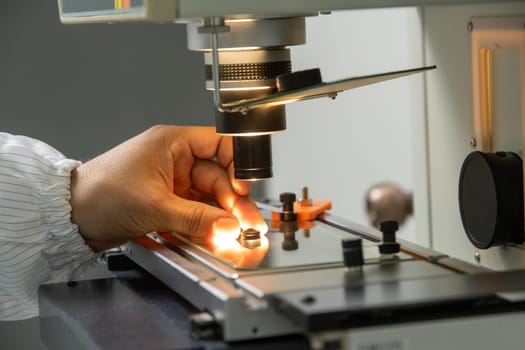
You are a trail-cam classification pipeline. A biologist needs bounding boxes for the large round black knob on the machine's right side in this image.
[459,151,524,249]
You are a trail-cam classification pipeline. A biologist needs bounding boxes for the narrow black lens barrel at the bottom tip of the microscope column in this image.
[233,135,273,180]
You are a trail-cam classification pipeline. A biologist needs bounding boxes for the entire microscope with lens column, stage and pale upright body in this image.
[36,0,525,350]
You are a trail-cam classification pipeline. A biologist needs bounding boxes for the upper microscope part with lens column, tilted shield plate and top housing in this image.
[59,1,435,181]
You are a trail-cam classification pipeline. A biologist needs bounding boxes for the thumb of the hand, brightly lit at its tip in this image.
[161,195,240,239]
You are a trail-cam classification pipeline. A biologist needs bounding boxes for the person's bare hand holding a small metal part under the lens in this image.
[70,126,267,251]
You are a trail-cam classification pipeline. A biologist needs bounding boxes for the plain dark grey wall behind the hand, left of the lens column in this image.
[0,0,213,350]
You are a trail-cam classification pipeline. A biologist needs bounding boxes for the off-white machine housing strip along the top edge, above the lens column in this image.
[59,0,516,23]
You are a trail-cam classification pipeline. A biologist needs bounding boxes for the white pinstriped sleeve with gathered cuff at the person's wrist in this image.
[0,133,95,321]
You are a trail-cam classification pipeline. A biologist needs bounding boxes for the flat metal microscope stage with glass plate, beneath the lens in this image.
[119,203,525,344]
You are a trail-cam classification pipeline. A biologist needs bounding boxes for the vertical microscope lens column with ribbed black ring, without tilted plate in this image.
[187,17,305,181]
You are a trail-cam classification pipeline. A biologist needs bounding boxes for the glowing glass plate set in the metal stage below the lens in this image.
[160,221,411,271]
